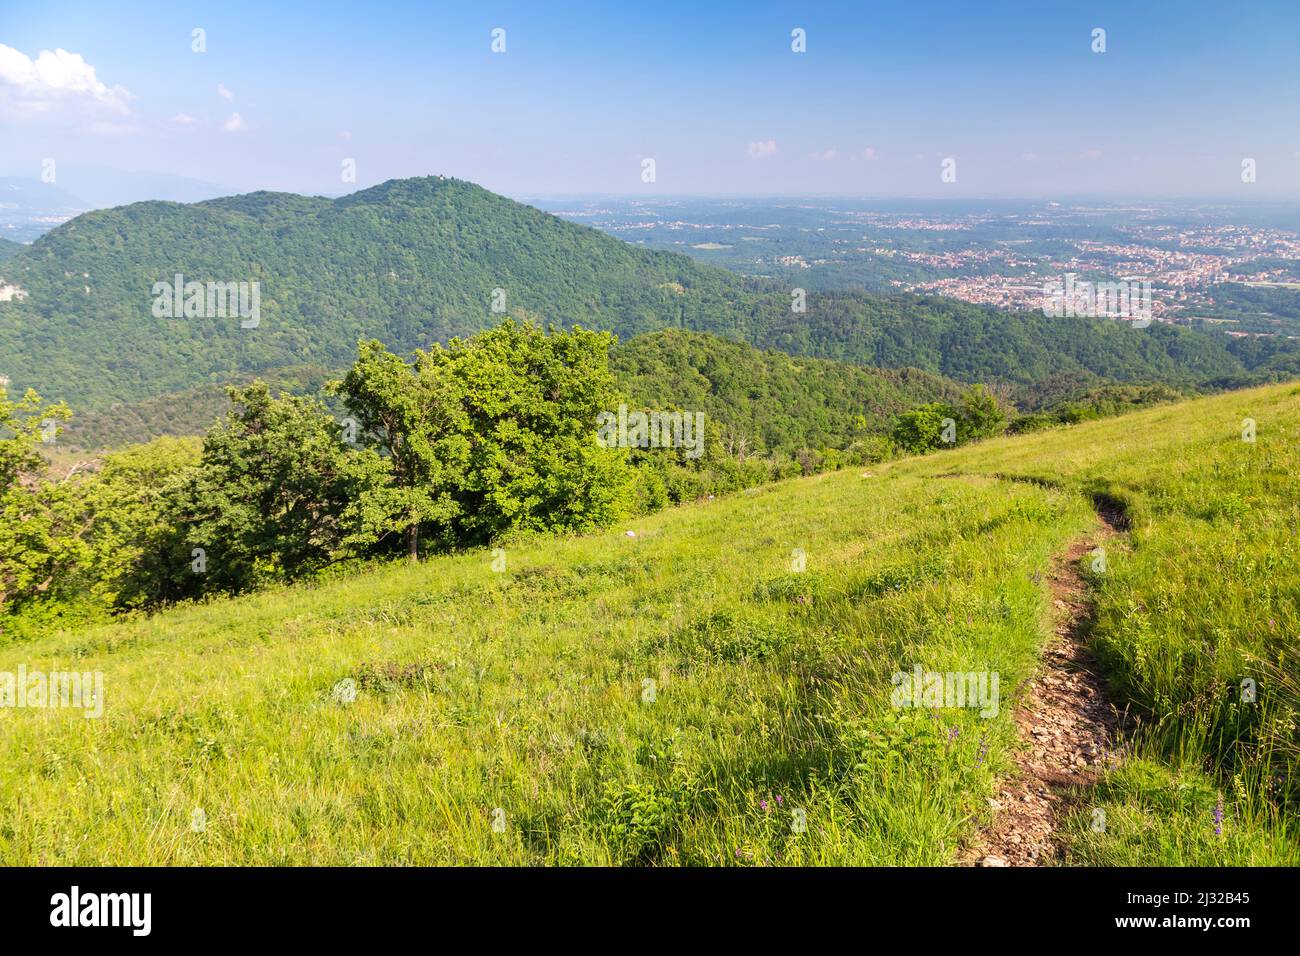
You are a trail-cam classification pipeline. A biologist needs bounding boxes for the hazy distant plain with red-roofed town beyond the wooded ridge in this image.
[537,199,1300,337]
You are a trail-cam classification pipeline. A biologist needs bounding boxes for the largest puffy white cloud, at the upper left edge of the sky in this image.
[0,43,131,118]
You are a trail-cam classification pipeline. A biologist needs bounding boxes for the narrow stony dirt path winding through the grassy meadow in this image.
[967,502,1127,866]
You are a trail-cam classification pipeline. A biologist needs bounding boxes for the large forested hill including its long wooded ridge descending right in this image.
[0,177,1292,408]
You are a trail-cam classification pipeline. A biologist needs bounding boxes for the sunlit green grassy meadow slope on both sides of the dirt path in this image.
[0,384,1300,865]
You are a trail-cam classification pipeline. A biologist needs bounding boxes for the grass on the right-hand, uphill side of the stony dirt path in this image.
[904,384,1300,865]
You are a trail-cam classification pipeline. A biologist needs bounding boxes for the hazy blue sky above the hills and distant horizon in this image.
[0,0,1300,199]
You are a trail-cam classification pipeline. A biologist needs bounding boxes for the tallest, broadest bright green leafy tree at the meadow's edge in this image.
[337,320,632,559]
